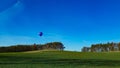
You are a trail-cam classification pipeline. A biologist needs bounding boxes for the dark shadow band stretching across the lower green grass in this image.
[0,56,120,66]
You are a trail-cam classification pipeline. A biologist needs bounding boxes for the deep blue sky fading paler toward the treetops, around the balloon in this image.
[0,0,120,51]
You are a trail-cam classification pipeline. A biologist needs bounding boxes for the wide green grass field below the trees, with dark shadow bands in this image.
[0,51,120,68]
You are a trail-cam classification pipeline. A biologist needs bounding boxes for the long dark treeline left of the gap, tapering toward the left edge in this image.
[0,42,65,52]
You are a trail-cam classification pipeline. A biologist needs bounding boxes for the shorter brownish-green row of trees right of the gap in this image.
[82,42,120,52]
